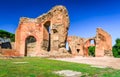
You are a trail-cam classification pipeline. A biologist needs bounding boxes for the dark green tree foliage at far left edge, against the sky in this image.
[0,30,15,42]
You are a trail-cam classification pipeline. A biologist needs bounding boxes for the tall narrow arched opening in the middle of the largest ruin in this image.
[42,21,51,51]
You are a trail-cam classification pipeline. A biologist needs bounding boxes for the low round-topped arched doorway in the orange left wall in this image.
[24,36,36,56]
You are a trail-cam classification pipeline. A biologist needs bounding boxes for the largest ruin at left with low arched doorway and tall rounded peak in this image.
[15,6,69,56]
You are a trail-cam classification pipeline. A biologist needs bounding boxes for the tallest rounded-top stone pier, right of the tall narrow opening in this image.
[51,6,69,52]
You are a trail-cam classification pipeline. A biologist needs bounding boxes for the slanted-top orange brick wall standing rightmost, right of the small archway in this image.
[95,28,112,56]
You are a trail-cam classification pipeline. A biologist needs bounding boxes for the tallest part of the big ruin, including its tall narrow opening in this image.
[37,6,69,52]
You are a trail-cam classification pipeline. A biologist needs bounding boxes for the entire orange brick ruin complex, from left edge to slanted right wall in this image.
[0,5,112,57]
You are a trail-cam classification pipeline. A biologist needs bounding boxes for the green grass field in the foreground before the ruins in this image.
[0,57,120,77]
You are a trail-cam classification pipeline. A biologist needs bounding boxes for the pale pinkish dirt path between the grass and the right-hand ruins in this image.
[52,56,120,69]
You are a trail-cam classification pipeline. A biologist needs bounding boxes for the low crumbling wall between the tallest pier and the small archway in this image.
[67,36,95,56]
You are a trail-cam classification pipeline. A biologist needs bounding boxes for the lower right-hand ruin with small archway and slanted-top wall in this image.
[67,28,112,57]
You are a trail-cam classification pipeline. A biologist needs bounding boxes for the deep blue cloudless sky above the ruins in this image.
[0,0,120,45]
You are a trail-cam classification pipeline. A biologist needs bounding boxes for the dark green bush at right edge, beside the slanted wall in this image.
[112,38,120,57]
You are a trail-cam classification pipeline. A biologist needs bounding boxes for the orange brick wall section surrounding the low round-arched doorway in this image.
[15,17,43,56]
